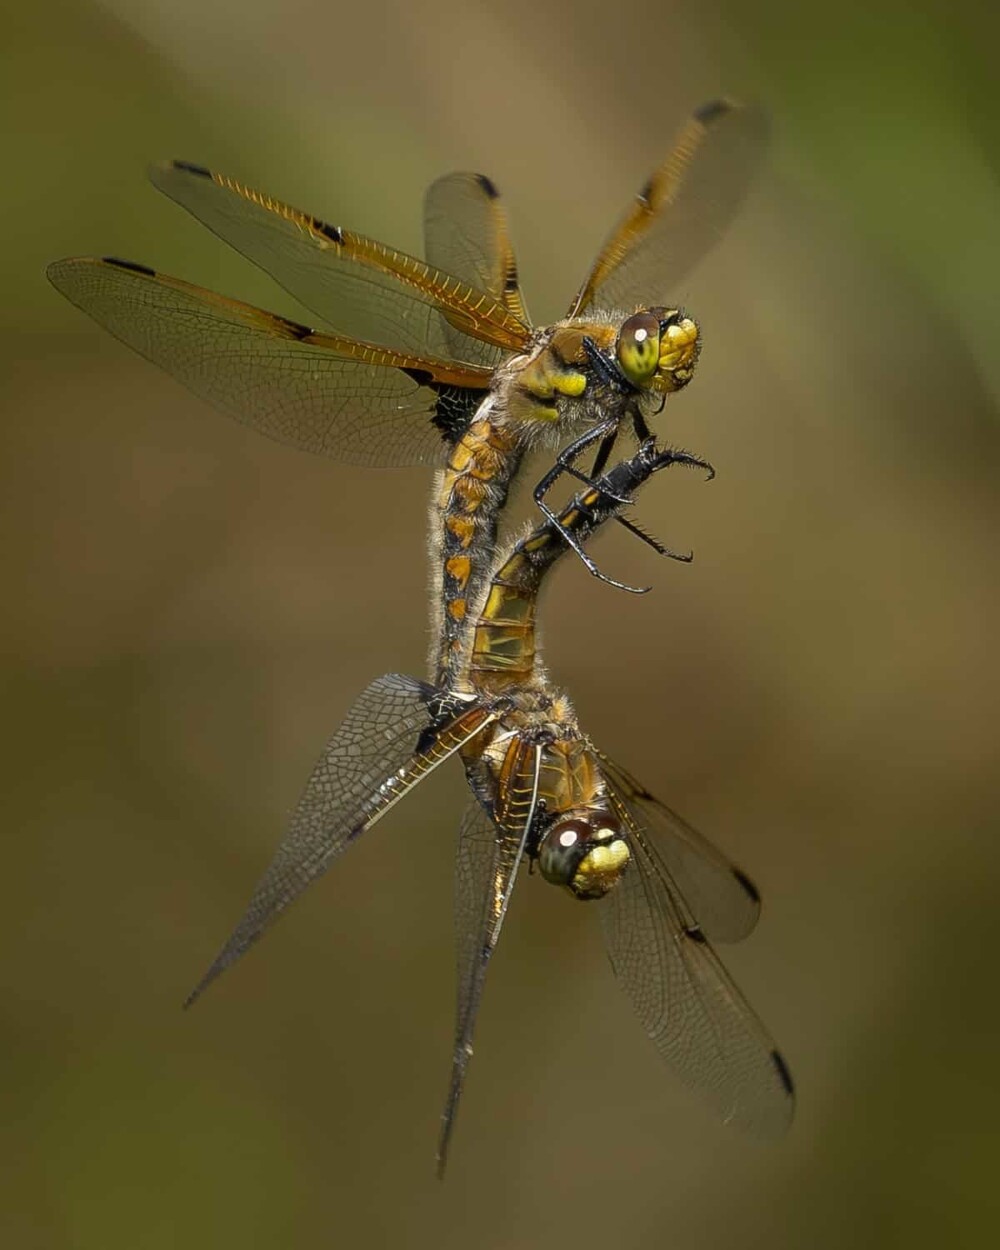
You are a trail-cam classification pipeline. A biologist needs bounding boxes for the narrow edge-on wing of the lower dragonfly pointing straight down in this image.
[438,739,540,1175]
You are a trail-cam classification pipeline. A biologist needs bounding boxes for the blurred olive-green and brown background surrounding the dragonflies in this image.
[0,0,1000,1250]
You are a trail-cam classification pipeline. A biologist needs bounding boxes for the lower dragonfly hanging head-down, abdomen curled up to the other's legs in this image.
[188,439,794,1174]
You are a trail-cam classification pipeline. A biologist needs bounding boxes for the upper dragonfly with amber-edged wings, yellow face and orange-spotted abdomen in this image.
[48,100,768,685]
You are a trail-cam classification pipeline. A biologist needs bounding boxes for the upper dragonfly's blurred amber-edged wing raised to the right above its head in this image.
[570,100,769,315]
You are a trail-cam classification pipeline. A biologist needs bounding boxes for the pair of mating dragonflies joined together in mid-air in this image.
[49,101,794,1168]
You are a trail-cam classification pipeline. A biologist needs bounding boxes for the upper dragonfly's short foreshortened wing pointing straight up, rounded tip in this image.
[424,173,528,366]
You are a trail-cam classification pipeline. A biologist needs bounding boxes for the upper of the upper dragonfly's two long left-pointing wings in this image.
[150,161,529,360]
